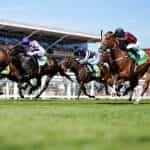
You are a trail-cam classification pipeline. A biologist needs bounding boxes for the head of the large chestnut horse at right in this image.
[100,31,119,51]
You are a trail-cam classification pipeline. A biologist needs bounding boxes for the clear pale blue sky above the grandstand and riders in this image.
[0,0,150,47]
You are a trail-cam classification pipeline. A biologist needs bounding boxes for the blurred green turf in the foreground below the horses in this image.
[0,100,150,150]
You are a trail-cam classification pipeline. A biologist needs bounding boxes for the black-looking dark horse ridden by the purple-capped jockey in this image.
[10,45,72,98]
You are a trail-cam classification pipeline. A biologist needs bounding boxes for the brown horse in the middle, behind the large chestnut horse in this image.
[60,57,112,100]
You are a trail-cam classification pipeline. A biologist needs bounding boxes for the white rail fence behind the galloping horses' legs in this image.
[0,74,150,99]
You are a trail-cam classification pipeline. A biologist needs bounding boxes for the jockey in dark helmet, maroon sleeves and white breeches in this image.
[114,28,140,58]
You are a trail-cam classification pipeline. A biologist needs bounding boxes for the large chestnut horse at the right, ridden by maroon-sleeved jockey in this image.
[100,32,150,101]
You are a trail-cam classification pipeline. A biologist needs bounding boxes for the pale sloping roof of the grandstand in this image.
[0,20,99,42]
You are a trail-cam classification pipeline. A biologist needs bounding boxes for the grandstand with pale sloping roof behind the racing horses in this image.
[0,21,99,61]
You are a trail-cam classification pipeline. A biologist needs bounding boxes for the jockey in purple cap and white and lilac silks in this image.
[21,37,47,66]
